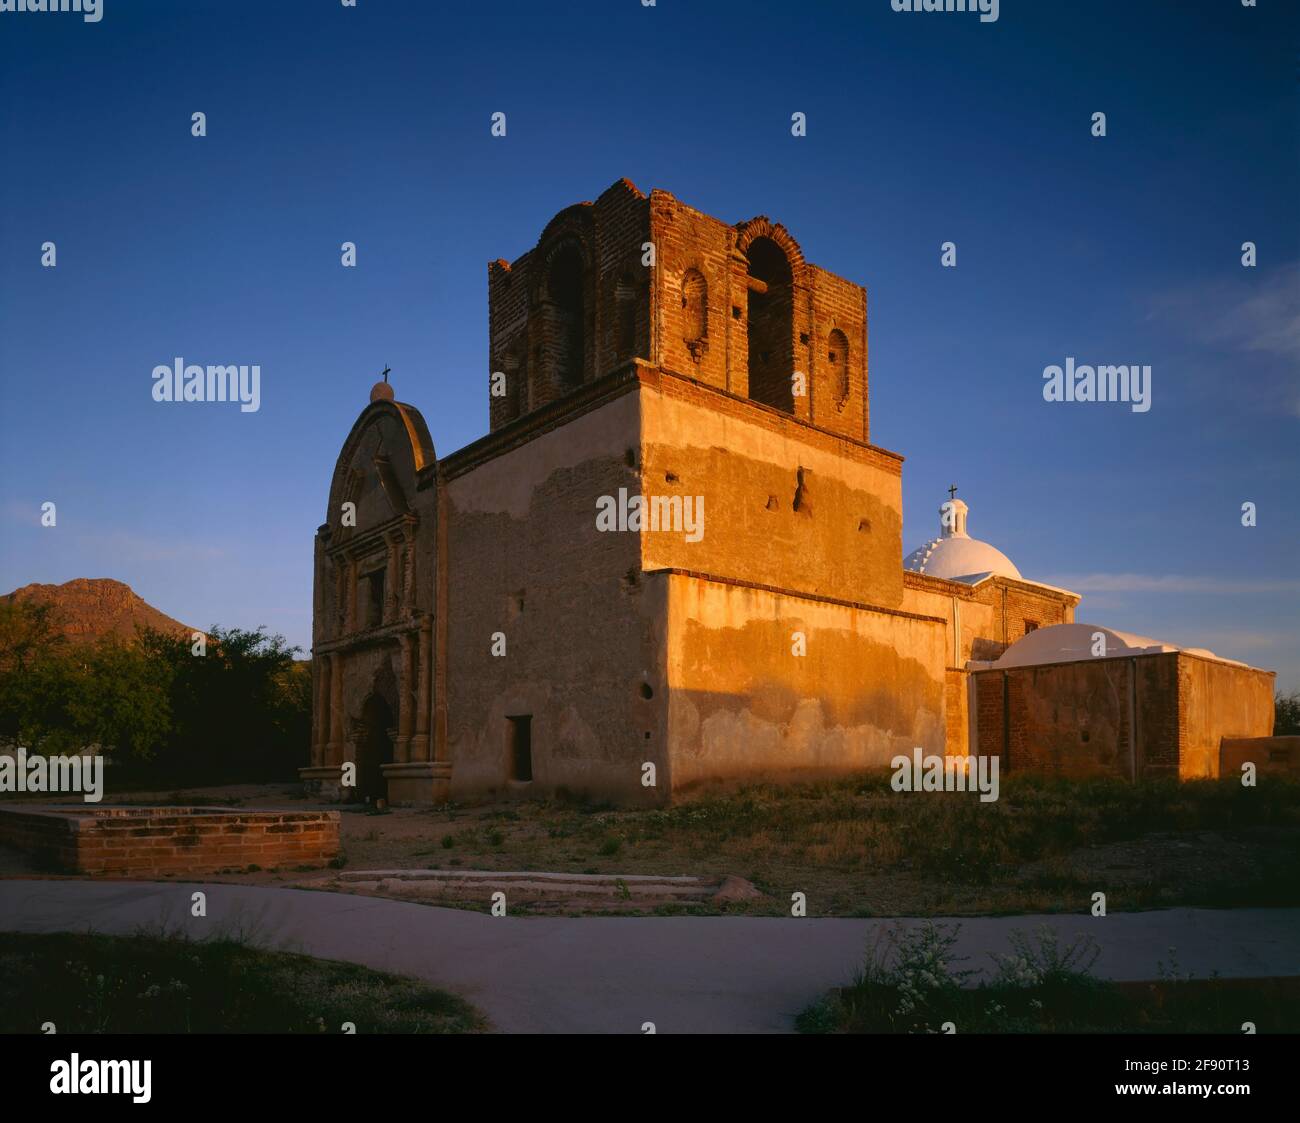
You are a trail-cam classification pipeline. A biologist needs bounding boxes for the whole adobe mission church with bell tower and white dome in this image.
[302,179,1273,806]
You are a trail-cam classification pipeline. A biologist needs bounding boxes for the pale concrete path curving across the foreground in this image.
[0,880,1300,1033]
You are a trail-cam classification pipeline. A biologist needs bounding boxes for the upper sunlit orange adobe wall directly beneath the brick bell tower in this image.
[640,370,902,608]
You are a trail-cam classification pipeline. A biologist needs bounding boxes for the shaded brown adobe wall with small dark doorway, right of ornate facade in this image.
[443,393,666,805]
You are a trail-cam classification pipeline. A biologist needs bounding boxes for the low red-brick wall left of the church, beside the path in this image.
[0,807,339,876]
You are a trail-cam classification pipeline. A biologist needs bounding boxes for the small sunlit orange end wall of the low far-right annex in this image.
[1178,652,1274,780]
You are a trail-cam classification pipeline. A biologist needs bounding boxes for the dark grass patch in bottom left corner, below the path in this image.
[0,933,486,1033]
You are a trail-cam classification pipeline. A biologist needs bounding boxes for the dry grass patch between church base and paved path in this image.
[332,769,1300,916]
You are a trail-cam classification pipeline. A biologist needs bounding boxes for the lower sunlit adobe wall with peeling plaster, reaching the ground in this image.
[665,572,944,794]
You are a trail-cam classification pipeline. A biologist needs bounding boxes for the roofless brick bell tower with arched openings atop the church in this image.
[488,179,870,442]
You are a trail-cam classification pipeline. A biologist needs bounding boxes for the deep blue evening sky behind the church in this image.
[0,0,1300,690]
